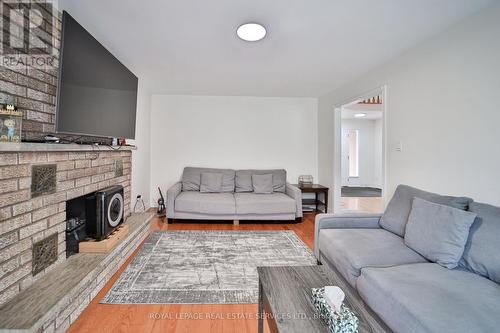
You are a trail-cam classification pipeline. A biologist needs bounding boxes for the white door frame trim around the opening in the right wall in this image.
[332,85,388,213]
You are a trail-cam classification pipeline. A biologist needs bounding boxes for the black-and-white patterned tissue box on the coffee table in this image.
[312,288,359,333]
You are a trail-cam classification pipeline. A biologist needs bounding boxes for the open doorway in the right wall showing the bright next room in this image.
[334,87,386,213]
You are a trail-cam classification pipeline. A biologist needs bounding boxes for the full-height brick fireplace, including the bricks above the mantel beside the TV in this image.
[0,1,137,306]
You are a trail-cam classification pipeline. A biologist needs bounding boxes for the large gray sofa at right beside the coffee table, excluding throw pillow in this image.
[315,185,500,333]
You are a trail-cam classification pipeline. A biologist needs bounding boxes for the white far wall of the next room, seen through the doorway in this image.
[342,119,382,188]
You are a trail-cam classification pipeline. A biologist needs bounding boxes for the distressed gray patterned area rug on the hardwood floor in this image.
[101,231,316,304]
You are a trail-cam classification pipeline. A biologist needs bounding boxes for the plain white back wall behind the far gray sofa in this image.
[151,95,318,200]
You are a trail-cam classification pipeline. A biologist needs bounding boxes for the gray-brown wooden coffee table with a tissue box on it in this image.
[257,265,391,333]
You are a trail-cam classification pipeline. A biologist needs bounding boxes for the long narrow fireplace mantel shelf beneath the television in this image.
[0,142,137,152]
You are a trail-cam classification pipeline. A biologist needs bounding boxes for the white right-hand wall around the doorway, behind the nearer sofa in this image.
[318,5,500,205]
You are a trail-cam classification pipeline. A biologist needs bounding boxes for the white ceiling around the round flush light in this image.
[59,0,495,97]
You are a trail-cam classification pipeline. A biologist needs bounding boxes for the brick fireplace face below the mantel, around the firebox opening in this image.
[0,151,132,305]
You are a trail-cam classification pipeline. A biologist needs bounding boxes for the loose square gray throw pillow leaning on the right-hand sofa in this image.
[404,198,477,269]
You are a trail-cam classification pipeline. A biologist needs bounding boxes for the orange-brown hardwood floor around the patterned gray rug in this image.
[68,213,315,333]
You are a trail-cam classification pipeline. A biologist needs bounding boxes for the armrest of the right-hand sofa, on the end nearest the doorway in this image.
[314,214,382,260]
